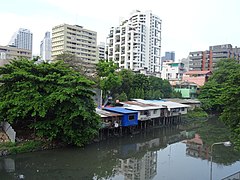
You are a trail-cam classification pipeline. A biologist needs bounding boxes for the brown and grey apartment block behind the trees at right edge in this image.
[189,44,240,71]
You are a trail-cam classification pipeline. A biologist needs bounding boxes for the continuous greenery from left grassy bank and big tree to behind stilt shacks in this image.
[0,53,182,153]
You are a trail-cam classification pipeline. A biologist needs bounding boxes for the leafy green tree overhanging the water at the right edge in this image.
[199,59,240,149]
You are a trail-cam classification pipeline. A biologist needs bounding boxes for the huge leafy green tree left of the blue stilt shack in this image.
[0,59,100,146]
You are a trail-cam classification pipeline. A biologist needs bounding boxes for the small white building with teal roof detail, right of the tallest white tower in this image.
[161,60,184,81]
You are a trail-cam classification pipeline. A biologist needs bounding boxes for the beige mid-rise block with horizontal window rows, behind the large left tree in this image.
[52,24,98,73]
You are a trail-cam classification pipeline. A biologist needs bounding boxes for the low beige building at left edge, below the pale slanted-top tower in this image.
[0,46,32,66]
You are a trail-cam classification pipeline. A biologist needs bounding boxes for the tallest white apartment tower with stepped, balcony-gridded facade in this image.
[107,10,162,72]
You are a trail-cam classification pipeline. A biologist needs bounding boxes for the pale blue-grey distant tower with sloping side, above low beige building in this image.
[9,28,33,51]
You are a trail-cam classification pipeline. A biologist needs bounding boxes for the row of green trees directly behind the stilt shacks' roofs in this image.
[94,60,174,103]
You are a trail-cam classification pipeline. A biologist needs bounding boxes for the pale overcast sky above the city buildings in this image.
[0,0,240,60]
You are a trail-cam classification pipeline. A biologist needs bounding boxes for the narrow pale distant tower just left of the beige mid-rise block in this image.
[40,32,52,61]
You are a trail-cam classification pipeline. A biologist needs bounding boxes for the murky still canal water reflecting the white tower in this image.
[0,117,240,180]
